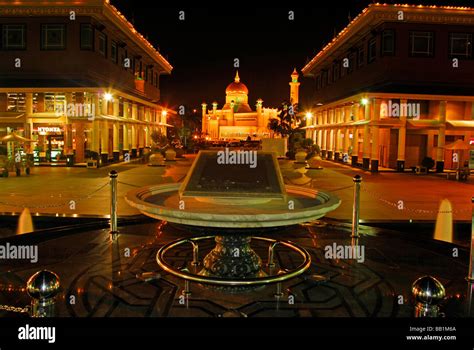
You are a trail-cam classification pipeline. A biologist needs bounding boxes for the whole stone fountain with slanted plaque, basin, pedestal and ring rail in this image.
[126,151,340,291]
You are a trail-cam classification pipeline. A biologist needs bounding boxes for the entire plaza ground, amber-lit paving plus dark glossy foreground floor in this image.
[0,156,474,317]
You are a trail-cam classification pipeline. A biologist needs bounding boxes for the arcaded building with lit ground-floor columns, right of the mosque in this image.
[302,4,474,172]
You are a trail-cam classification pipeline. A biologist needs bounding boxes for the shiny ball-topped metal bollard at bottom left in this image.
[26,270,60,317]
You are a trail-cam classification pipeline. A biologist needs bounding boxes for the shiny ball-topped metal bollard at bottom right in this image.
[411,276,446,317]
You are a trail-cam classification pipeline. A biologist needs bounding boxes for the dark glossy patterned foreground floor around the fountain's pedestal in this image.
[0,219,468,317]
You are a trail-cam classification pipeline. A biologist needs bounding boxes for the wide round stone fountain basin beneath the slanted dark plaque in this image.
[125,183,341,228]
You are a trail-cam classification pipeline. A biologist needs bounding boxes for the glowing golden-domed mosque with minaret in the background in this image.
[202,69,300,140]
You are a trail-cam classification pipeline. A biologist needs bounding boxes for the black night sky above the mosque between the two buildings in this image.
[111,0,472,111]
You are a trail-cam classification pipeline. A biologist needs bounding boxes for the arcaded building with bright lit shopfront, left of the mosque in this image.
[0,0,173,165]
